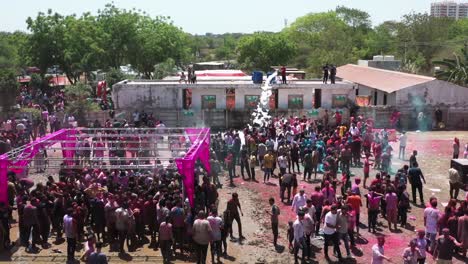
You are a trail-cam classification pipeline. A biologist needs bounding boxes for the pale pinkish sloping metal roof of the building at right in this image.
[336,64,435,93]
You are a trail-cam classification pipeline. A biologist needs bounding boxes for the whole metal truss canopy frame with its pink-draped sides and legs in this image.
[0,127,210,206]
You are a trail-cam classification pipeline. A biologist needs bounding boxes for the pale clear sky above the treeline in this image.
[0,0,446,34]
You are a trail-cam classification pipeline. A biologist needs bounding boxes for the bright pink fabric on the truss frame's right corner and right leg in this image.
[176,128,211,206]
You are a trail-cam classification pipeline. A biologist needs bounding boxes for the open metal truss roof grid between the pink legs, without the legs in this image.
[1,127,205,170]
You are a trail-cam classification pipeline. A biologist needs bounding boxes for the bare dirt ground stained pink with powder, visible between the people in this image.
[0,132,468,264]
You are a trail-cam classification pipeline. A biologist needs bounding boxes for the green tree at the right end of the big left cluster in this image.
[129,17,188,79]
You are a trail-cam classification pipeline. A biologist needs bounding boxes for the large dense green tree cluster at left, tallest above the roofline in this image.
[27,4,189,80]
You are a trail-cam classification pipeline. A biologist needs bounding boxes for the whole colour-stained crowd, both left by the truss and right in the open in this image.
[0,103,468,263]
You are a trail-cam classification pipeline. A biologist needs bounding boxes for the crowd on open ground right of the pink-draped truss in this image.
[212,114,468,263]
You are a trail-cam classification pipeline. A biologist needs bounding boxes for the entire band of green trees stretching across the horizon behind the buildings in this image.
[0,4,468,84]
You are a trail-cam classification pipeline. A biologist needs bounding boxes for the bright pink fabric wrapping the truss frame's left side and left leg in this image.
[0,129,77,203]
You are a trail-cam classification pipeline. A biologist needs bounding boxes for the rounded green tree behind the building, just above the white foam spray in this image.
[237,32,296,72]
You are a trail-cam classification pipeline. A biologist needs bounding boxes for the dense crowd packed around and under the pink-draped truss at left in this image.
[0,117,250,263]
